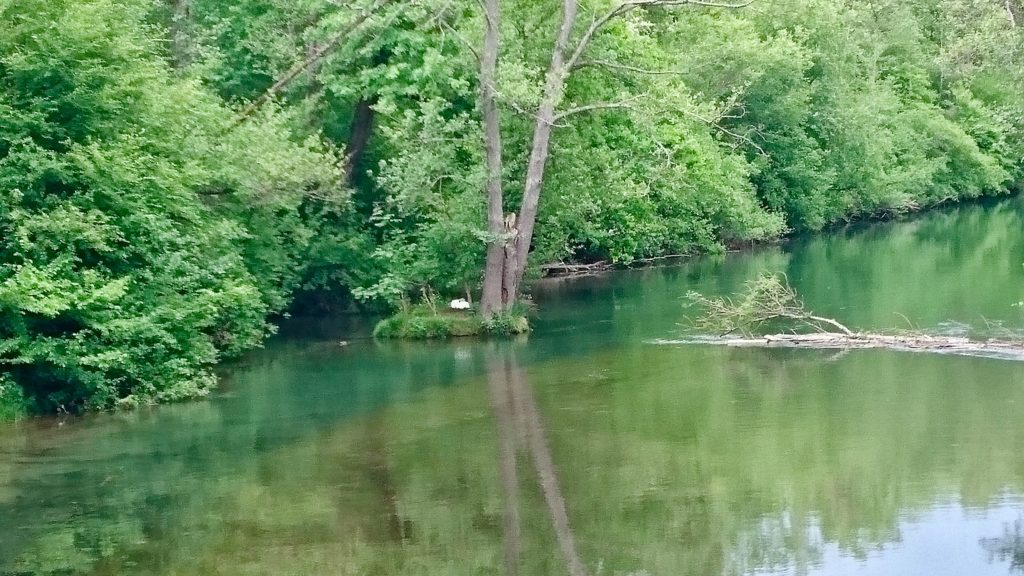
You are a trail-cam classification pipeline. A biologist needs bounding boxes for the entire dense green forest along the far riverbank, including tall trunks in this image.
[0,0,1024,418]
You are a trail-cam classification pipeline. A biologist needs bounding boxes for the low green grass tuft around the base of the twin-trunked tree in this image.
[374,304,529,340]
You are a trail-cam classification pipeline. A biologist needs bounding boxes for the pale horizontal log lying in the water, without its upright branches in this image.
[657,332,1024,360]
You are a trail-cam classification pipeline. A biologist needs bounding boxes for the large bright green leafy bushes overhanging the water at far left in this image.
[0,0,343,412]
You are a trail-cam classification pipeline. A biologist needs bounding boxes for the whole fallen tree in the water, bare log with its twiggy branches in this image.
[686,275,1024,360]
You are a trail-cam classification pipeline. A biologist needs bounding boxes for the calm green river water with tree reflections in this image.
[0,200,1024,576]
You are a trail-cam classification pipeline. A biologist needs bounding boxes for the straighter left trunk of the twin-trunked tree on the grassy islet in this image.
[480,0,513,318]
